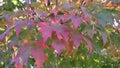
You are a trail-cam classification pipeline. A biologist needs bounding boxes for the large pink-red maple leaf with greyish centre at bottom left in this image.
[13,41,47,68]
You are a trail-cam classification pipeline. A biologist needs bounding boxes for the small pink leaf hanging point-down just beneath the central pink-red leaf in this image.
[52,40,65,55]
